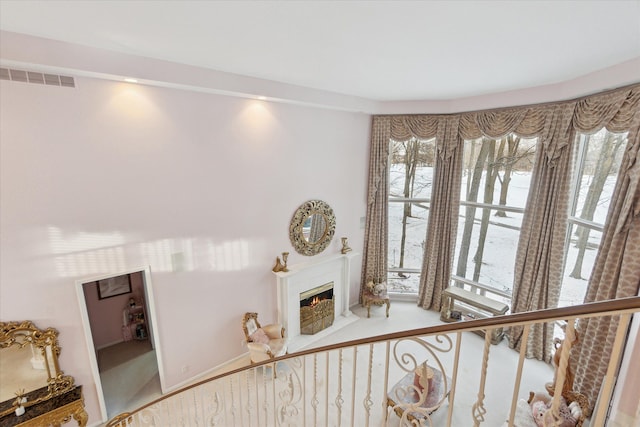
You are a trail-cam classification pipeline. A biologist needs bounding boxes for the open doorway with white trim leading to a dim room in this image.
[76,268,164,422]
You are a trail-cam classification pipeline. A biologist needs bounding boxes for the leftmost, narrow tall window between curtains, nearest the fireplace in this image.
[387,139,435,295]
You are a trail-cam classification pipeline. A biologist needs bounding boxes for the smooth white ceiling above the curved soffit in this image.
[0,0,640,101]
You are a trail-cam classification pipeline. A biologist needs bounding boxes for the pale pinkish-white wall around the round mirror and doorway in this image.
[0,78,370,424]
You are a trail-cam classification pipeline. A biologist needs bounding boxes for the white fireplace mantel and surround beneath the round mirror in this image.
[274,251,359,352]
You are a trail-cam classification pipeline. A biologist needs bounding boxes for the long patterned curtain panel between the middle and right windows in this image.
[507,104,574,363]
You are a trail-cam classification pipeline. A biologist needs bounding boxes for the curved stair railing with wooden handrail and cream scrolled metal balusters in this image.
[108,297,640,427]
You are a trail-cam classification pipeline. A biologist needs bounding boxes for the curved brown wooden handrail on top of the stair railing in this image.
[107,297,640,426]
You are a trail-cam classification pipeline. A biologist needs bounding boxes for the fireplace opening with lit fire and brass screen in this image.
[300,282,334,335]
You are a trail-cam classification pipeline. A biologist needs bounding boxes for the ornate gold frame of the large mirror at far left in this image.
[0,320,74,417]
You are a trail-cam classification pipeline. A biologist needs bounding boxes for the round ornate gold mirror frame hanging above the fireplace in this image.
[289,200,336,256]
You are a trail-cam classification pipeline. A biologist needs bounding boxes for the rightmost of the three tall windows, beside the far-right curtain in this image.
[558,128,627,307]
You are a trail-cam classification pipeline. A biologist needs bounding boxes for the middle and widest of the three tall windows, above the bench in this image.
[452,134,537,303]
